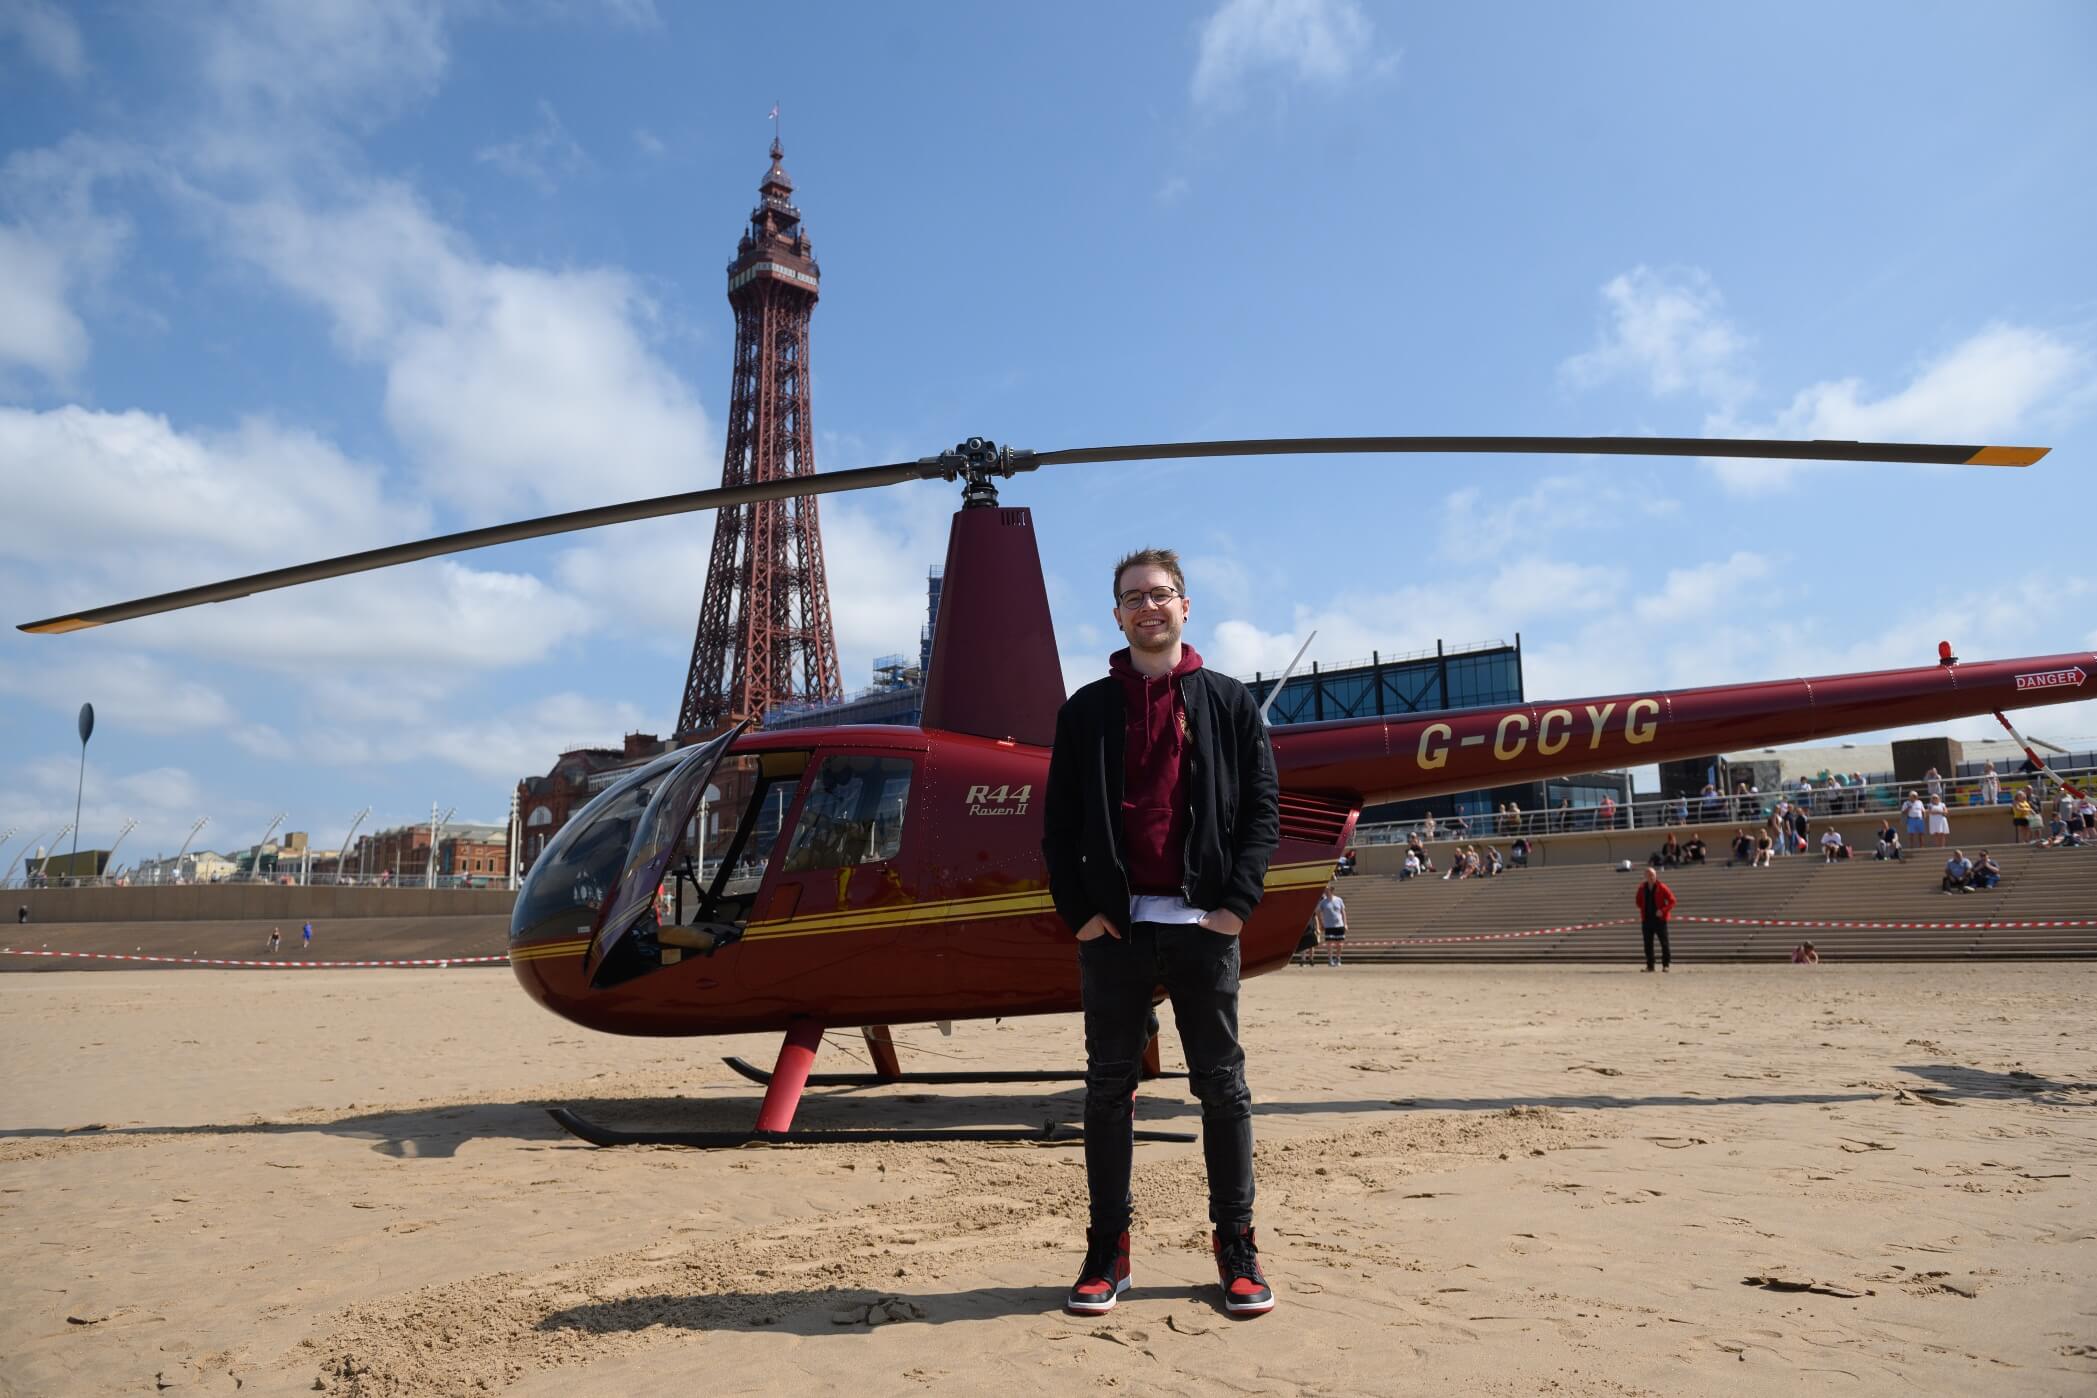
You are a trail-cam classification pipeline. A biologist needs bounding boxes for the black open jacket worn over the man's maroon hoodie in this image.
[1042,669,1281,933]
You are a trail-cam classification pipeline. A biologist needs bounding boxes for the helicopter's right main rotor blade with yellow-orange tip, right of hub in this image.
[1030,436,2049,465]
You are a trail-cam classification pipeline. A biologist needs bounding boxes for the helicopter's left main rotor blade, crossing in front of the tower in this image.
[19,461,939,635]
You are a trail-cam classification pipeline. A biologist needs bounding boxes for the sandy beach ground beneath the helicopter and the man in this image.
[0,958,2097,1396]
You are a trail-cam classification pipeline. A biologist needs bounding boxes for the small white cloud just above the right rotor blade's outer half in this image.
[1558,266,1753,407]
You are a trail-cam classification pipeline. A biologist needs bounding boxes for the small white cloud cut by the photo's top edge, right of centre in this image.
[1191,0,1392,107]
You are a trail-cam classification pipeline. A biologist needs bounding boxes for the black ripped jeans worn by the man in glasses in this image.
[1078,922,1252,1232]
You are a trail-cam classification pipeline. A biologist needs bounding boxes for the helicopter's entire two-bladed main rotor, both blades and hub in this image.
[19,436,2049,635]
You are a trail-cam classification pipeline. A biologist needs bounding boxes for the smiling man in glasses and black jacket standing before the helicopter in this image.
[1042,549,1281,1316]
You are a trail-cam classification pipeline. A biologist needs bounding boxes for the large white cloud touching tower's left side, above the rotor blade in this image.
[216,182,719,518]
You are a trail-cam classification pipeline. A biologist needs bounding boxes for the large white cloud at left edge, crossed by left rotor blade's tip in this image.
[0,407,591,673]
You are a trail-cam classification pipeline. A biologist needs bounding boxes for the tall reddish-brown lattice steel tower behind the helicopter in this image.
[677,138,845,736]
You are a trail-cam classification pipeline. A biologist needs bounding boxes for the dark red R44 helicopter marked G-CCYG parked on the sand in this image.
[21,436,2097,1146]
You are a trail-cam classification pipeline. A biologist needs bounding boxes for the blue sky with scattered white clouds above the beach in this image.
[0,0,2097,859]
